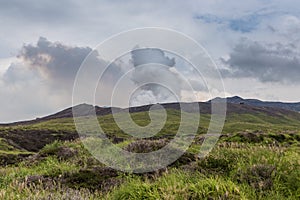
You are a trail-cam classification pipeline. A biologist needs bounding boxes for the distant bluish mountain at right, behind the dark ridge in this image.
[214,96,300,112]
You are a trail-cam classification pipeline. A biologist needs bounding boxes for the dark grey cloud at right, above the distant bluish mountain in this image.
[223,39,300,83]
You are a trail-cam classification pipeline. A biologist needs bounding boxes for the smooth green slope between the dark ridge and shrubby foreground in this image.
[0,102,300,151]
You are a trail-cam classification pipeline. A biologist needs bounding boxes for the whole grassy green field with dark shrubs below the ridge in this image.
[0,110,300,200]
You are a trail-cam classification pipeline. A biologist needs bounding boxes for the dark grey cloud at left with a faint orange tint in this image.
[19,37,92,79]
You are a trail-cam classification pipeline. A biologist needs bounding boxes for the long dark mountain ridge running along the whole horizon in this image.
[0,96,300,126]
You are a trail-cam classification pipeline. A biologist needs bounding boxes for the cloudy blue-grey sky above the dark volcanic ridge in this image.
[0,0,300,123]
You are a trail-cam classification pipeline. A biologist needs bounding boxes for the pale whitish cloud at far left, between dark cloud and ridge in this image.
[0,61,70,122]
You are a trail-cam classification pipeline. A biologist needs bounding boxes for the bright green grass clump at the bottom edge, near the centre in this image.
[107,169,245,199]
